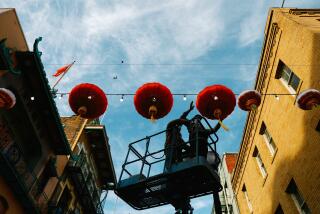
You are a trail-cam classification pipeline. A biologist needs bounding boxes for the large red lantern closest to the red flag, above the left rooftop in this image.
[69,83,108,119]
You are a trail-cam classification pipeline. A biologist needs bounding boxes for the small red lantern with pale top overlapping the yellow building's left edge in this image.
[238,90,261,111]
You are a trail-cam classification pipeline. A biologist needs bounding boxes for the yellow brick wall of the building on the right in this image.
[232,9,320,213]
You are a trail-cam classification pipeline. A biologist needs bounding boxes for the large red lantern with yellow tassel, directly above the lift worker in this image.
[196,85,236,130]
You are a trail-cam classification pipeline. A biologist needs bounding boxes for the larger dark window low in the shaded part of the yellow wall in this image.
[286,179,311,214]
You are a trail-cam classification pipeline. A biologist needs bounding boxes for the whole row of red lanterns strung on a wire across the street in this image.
[0,82,320,123]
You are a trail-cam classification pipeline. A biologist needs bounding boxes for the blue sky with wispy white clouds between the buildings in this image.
[0,0,320,214]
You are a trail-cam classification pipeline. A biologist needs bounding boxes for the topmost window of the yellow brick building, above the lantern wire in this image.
[276,60,300,92]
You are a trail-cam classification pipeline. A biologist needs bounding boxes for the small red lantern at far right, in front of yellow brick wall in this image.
[297,89,320,110]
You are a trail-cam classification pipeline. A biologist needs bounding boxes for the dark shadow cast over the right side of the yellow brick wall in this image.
[269,34,320,213]
